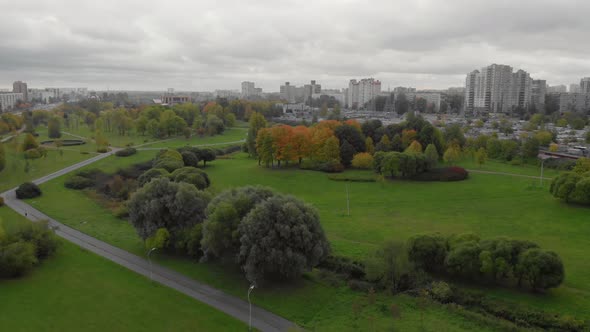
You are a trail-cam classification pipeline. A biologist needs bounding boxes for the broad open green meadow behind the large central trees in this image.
[201,154,590,319]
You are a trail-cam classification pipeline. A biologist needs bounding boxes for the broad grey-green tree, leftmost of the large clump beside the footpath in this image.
[127,178,211,240]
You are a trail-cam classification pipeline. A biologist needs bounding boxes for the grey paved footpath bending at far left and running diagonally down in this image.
[0,149,295,331]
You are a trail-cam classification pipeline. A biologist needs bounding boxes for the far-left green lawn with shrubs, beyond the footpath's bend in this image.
[0,130,95,192]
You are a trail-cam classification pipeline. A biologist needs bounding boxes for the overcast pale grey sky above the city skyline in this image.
[0,0,590,91]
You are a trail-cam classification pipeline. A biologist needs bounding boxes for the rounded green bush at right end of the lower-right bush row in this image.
[517,249,564,290]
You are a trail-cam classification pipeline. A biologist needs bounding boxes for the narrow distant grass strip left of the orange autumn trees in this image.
[142,127,248,148]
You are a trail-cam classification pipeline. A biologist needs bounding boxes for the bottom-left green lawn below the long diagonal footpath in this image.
[0,207,247,331]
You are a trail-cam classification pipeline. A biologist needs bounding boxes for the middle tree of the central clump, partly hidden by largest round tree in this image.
[201,186,274,259]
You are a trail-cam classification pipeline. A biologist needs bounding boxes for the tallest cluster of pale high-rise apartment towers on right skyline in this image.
[465,64,533,113]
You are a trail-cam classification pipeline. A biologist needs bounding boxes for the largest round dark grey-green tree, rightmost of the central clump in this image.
[238,195,330,282]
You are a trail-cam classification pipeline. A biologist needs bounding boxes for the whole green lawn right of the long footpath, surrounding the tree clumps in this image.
[26,151,590,331]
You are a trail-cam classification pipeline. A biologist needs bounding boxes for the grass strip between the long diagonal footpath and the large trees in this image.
[29,151,508,331]
